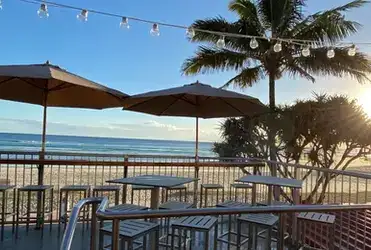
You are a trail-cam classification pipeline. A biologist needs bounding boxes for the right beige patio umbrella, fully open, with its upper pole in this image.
[123,82,267,158]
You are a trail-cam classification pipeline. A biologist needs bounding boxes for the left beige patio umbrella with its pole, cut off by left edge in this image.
[0,62,128,185]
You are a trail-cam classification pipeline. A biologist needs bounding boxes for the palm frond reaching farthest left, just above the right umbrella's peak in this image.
[182,46,249,75]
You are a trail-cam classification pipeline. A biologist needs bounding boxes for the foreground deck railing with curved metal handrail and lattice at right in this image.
[60,198,371,250]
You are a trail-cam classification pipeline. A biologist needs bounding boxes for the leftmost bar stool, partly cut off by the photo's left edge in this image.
[0,184,16,241]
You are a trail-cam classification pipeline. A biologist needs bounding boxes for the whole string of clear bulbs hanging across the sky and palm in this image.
[16,0,371,56]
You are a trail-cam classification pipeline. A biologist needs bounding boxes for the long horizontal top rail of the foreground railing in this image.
[97,205,371,220]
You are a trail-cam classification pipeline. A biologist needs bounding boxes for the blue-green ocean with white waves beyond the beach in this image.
[0,133,215,156]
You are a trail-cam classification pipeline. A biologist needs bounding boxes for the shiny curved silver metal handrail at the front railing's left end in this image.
[60,197,108,250]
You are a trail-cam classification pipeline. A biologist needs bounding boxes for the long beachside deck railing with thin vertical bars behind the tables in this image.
[0,151,371,222]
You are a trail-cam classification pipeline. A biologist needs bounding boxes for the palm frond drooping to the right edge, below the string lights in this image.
[295,47,371,83]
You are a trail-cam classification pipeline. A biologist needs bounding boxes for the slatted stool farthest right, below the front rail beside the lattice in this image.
[297,212,335,250]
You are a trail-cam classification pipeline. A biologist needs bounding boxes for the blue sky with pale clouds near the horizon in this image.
[0,0,371,141]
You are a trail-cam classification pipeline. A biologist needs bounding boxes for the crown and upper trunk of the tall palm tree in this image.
[182,0,371,110]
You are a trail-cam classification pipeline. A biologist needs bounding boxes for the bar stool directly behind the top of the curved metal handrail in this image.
[59,185,90,226]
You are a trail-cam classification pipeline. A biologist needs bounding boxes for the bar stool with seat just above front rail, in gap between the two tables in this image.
[216,200,251,246]
